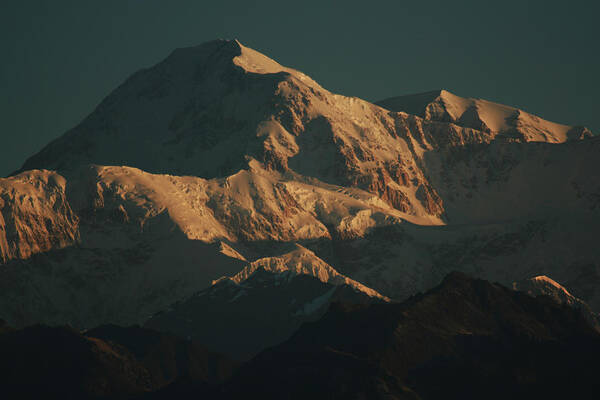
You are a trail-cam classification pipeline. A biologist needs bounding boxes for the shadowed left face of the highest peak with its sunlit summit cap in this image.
[21,40,318,178]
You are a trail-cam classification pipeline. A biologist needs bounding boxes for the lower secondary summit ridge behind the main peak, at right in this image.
[376,90,592,143]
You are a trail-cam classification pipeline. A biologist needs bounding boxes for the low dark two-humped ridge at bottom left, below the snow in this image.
[0,325,238,399]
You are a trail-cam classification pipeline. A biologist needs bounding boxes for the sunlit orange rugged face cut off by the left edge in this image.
[0,170,79,262]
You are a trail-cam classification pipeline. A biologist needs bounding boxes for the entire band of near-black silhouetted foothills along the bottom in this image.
[0,273,600,400]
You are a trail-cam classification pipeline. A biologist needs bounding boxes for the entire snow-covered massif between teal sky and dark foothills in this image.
[0,40,600,327]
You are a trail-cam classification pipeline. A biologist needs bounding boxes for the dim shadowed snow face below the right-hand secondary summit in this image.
[424,137,600,224]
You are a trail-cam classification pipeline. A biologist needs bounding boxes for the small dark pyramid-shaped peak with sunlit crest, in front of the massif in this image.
[146,246,389,360]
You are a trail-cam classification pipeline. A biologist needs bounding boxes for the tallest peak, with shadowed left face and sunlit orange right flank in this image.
[15,40,450,222]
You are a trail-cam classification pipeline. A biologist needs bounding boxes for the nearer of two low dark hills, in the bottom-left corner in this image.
[0,325,153,399]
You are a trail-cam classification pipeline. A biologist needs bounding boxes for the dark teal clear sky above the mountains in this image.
[0,0,600,176]
